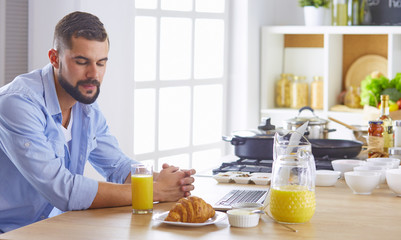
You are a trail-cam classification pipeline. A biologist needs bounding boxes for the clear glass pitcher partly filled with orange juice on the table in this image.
[269,131,316,223]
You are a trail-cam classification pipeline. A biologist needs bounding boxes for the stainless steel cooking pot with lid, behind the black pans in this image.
[285,106,335,139]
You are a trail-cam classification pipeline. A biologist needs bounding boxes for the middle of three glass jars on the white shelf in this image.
[291,76,309,109]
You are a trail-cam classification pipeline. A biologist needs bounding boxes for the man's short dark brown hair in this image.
[53,11,110,53]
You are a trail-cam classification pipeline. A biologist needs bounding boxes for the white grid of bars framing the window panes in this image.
[134,0,230,171]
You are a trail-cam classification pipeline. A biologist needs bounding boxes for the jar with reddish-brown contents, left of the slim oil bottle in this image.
[368,120,384,158]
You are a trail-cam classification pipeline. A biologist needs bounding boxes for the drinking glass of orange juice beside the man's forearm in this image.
[131,164,153,214]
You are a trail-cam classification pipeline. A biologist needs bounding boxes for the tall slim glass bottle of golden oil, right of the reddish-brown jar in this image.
[378,95,394,153]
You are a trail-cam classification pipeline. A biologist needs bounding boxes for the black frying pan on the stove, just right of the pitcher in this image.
[309,139,363,158]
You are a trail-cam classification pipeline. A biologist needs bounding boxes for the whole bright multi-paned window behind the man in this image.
[134,0,228,172]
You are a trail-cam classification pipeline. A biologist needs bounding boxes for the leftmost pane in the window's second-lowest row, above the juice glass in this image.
[134,89,156,154]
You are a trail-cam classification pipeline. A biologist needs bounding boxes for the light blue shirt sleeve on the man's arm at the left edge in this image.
[0,94,98,211]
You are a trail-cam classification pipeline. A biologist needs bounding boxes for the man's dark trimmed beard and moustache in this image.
[58,63,100,104]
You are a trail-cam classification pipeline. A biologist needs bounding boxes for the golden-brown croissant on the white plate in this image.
[165,196,215,223]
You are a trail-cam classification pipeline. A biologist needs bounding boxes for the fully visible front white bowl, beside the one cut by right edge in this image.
[344,171,381,195]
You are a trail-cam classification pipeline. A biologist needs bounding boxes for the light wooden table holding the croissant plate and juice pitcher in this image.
[0,177,401,240]
